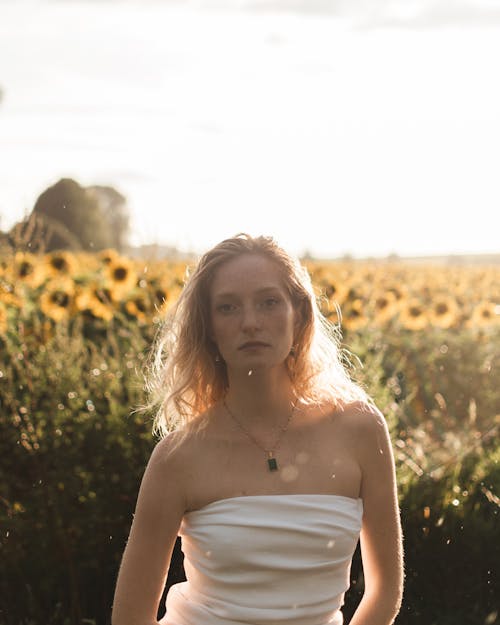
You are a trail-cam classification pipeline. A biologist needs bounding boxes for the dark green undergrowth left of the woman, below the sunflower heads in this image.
[0,324,153,625]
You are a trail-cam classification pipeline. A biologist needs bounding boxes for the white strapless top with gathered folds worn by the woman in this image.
[161,495,363,625]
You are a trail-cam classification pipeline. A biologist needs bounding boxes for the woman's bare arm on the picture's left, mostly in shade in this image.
[111,437,185,625]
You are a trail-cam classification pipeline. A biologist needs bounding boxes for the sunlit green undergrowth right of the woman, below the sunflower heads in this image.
[346,328,500,625]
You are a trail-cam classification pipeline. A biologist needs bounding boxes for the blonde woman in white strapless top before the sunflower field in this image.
[112,235,403,625]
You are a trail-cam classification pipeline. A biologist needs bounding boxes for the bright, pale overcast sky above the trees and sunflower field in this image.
[0,0,500,258]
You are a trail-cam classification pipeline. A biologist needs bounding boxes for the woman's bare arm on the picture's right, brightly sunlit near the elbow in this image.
[350,408,404,625]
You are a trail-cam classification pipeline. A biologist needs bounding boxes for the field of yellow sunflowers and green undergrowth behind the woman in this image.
[0,250,500,625]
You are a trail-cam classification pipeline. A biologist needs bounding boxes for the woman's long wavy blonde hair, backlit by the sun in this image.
[146,234,371,436]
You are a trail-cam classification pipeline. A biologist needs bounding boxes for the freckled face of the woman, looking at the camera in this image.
[210,253,298,371]
